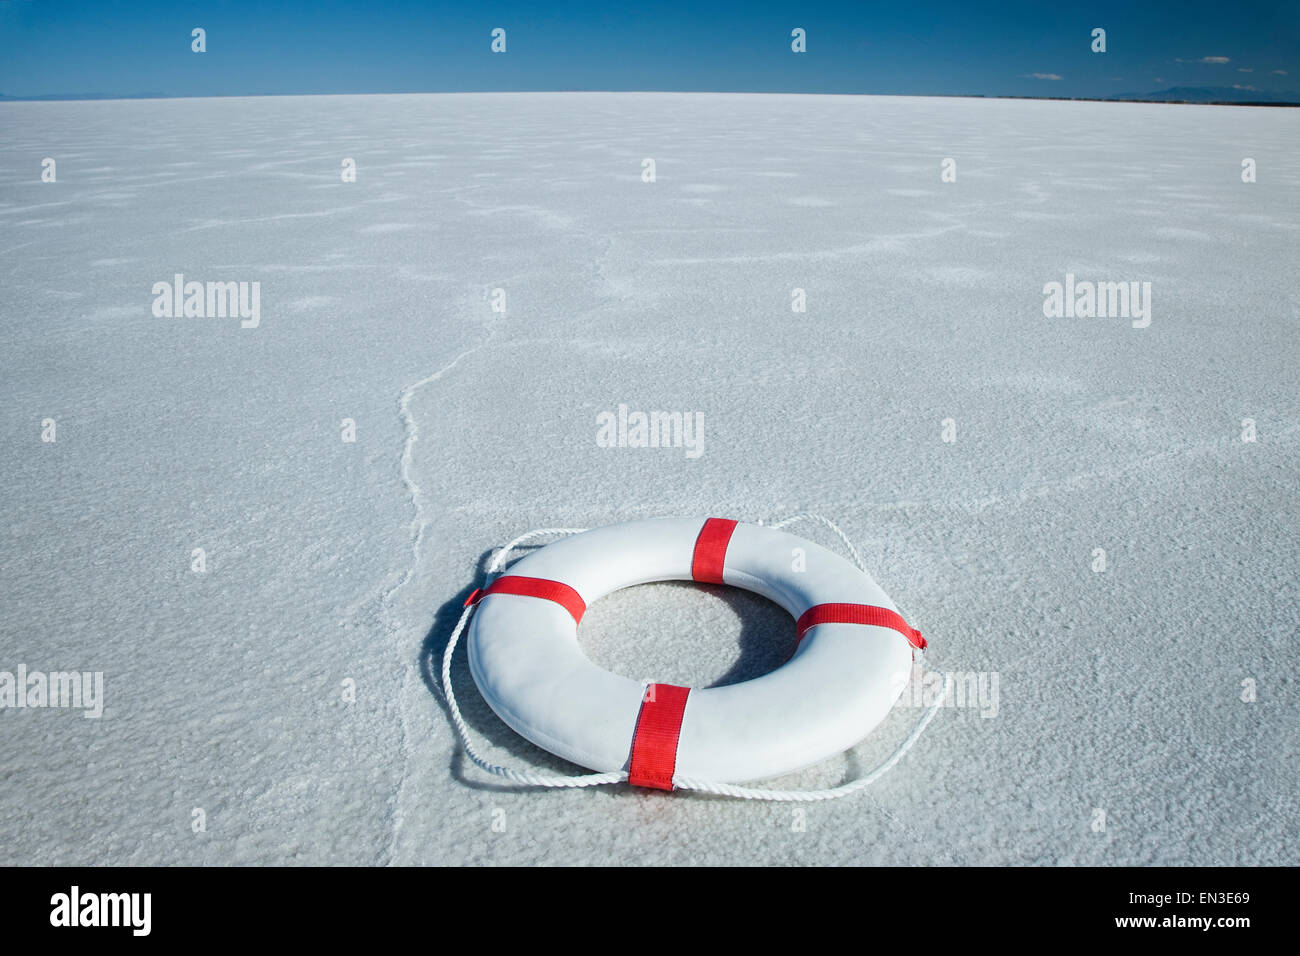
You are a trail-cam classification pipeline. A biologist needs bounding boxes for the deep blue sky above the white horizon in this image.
[0,0,1300,96]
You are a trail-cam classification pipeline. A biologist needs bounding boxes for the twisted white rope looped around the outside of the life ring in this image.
[442,511,953,803]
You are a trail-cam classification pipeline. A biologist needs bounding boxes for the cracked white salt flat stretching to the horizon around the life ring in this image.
[0,94,1300,865]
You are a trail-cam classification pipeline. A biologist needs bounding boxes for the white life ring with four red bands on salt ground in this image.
[465,518,926,790]
